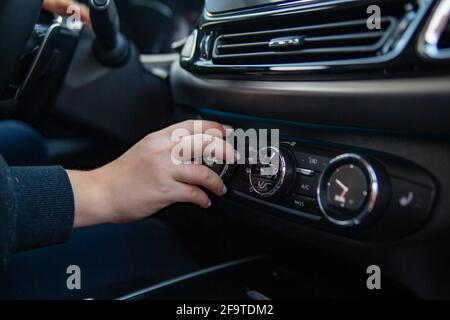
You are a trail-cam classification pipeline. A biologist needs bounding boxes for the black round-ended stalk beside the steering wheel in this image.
[89,0,130,67]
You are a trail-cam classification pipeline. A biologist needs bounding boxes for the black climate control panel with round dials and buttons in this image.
[225,141,436,239]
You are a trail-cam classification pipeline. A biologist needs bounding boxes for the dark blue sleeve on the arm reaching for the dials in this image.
[0,156,74,267]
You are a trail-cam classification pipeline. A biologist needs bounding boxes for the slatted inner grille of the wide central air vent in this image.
[213,16,397,64]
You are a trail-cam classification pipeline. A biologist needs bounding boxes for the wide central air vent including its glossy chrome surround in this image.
[196,0,428,71]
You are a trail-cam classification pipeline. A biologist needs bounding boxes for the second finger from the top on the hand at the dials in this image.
[172,134,235,163]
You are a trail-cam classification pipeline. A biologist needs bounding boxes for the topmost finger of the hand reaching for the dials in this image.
[164,120,227,138]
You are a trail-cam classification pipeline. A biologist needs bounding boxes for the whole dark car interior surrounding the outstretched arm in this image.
[0,0,450,301]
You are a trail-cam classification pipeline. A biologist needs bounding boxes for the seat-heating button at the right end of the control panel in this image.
[391,178,434,217]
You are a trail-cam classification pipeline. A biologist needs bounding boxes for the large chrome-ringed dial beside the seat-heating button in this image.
[317,154,388,227]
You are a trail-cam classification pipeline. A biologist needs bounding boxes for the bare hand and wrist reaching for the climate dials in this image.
[68,121,235,227]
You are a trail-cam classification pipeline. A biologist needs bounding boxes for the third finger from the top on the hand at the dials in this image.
[174,164,227,197]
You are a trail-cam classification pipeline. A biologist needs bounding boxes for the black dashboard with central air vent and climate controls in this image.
[171,0,450,298]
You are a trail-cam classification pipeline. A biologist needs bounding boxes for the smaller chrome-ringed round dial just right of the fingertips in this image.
[248,147,295,198]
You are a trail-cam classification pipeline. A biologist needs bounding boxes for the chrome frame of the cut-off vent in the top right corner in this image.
[417,0,450,60]
